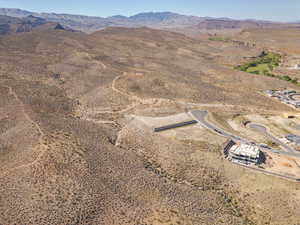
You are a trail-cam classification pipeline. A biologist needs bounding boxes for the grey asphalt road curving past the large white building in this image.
[190,110,300,158]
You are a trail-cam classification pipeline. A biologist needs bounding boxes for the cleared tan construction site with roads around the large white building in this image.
[146,110,300,181]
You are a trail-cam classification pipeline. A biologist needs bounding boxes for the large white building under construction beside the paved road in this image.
[224,140,264,165]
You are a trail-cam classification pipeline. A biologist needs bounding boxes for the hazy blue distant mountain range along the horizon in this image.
[0,8,295,33]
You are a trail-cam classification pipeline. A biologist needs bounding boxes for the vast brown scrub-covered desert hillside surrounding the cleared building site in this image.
[0,25,300,225]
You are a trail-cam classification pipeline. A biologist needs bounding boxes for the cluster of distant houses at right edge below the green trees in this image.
[265,90,300,108]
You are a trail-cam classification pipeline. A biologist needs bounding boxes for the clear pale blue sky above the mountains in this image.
[0,0,300,21]
